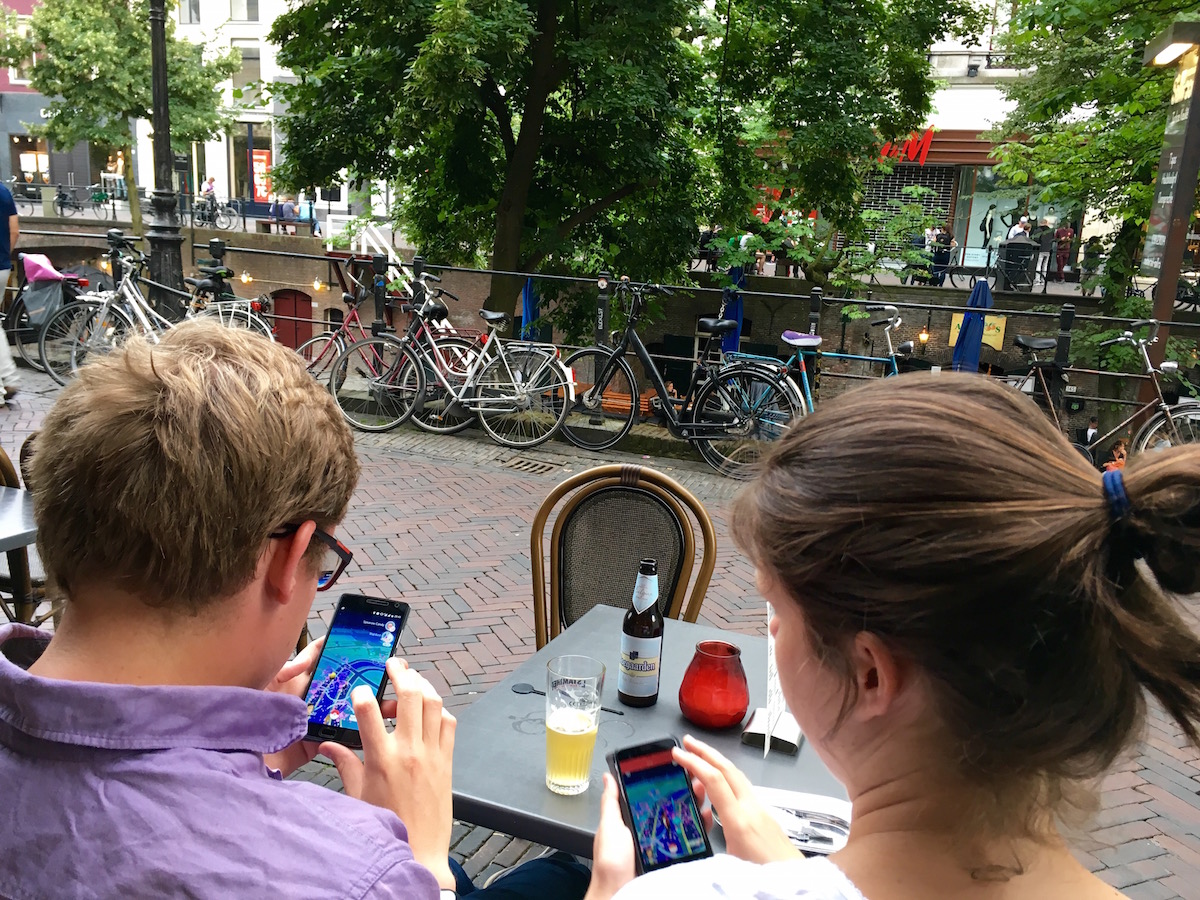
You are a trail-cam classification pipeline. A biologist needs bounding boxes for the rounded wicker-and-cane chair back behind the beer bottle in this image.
[529,464,716,649]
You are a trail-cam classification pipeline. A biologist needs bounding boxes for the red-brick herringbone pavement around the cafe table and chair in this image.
[9,364,1200,900]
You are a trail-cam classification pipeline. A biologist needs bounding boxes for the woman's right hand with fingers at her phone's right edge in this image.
[676,736,800,863]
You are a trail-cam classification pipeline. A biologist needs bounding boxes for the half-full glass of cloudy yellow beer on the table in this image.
[546,656,604,794]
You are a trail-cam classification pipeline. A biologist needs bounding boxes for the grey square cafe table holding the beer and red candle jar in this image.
[454,606,846,858]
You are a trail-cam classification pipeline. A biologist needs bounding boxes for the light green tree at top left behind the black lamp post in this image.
[0,0,241,232]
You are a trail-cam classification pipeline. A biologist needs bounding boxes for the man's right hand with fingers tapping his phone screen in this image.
[320,659,457,889]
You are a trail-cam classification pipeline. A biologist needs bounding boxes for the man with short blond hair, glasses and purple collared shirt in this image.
[0,320,588,900]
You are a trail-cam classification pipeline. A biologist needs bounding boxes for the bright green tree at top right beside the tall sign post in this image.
[996,0,1200,303]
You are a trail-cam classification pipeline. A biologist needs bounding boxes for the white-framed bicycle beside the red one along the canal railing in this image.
[329,286,575,449]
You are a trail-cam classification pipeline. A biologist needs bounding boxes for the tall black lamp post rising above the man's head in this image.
[146,0,184,319]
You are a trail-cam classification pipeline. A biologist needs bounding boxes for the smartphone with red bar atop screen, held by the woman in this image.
[607,738,713,874]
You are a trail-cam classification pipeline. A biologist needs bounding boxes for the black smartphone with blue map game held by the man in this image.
[305,594,408,749]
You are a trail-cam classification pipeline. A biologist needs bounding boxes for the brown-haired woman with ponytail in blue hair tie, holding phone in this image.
[589,373,1200,900]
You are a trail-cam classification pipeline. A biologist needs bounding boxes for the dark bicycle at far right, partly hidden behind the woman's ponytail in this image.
[1001,319,1200,463]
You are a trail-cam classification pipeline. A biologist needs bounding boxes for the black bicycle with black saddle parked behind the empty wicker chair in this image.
[563,277,803,478]
